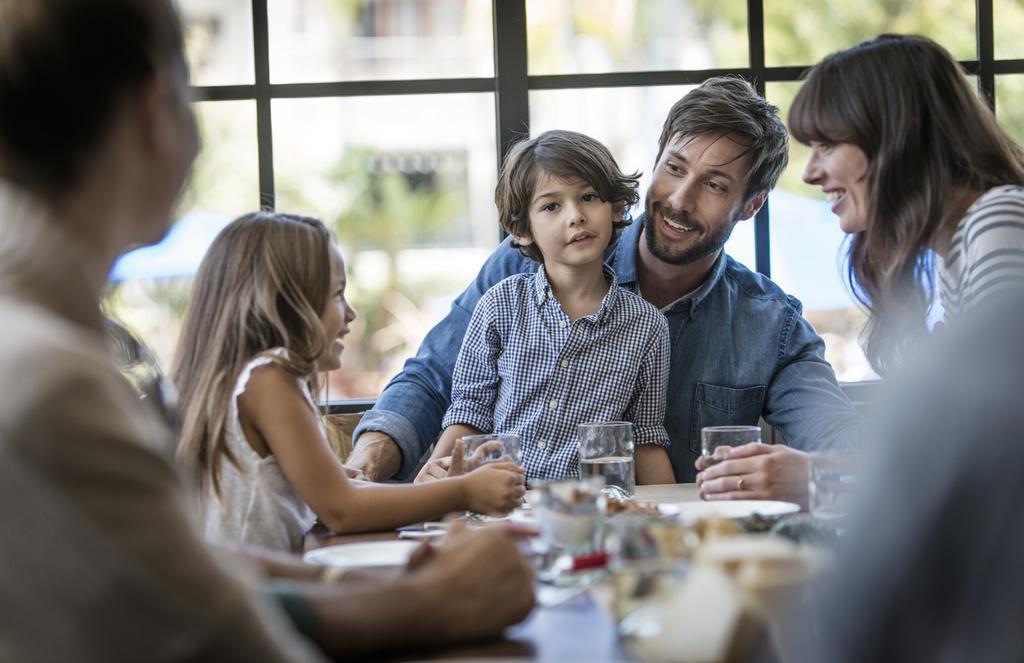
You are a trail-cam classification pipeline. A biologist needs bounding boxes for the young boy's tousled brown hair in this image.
[495,131,640,262]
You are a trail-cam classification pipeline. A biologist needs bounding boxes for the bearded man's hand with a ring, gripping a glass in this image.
[696,443,808,509]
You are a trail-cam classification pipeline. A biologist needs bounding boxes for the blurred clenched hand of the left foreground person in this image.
[409,524,534,640]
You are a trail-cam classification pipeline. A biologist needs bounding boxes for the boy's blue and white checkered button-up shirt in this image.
[442,267,669,479]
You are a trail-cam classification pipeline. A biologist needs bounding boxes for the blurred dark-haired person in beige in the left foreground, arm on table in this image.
[0,0,532,661]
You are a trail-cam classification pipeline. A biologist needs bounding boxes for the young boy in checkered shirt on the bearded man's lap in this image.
[417,131,675,484]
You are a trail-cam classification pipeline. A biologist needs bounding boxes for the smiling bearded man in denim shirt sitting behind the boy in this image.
[349,78,859,503]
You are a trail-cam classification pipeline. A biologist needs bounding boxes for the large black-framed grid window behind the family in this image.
[105,0,1024,398]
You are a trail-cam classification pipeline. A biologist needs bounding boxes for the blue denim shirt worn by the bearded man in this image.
[353,216,860,482]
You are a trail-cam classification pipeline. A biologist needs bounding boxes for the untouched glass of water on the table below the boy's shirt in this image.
[577,421,636,499]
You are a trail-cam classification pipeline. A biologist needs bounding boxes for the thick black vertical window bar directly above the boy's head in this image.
[492,0,529,168]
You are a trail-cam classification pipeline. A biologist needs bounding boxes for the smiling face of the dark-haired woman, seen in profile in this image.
[804,142,868,233]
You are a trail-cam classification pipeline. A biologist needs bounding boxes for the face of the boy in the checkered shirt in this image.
[516,170,624,265]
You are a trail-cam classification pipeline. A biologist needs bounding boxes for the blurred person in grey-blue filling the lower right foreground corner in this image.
[815,286,1024,663]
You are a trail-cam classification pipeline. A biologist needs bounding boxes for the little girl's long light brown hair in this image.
[171,212,331,496]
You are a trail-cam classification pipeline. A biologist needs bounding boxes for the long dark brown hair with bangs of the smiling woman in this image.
[790,35,1024,374]
